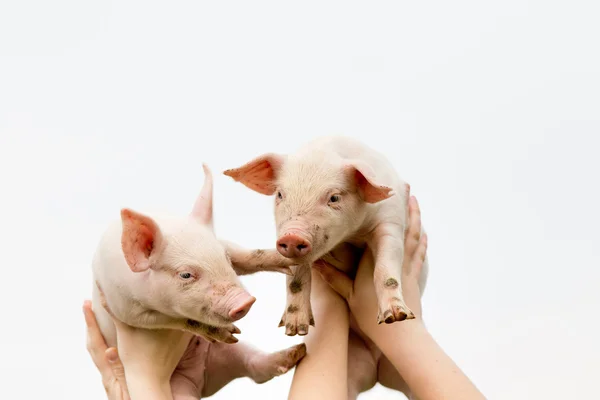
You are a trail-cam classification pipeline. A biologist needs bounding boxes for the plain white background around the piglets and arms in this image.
[0,0,600,399]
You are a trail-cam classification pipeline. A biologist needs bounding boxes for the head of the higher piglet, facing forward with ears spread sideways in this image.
[224,151,393,259]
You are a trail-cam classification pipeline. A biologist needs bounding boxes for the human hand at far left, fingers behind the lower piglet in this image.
[83,300,131,400]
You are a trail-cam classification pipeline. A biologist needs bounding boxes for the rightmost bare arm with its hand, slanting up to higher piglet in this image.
[315,197,485,400]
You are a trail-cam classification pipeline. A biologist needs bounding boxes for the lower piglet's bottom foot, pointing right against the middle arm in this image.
[250,343,306,383]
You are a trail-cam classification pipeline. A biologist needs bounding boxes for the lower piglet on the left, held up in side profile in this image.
[92,165,305,398]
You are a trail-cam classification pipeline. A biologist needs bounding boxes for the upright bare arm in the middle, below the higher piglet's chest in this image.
[288,271,350,400]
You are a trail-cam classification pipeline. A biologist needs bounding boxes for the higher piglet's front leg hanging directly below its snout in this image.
[279,264,315,336]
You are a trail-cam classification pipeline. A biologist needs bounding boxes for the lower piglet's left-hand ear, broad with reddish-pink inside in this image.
[121,208,162,272]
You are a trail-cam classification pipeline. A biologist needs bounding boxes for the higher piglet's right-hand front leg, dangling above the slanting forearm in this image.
[369,224,415,324]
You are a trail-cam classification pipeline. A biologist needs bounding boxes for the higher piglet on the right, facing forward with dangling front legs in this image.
[224,136,428,336]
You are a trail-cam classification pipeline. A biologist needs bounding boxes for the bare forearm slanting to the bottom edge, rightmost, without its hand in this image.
[373,320,485,400]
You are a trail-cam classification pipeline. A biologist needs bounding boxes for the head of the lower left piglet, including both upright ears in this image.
[121,167,256,326]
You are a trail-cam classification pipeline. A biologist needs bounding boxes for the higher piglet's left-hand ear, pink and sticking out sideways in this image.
[223,153,284,196]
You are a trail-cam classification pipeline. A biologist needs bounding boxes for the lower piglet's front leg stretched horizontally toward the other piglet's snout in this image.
[221,240,293,275]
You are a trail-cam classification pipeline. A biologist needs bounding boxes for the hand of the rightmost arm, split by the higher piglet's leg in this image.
[314,196,427,336]
